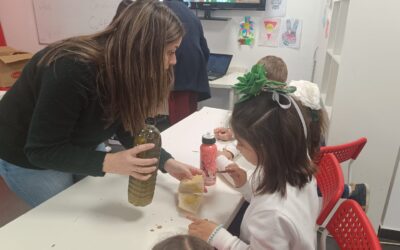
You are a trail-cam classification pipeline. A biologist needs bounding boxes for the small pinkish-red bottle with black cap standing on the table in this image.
[200,133,217,186]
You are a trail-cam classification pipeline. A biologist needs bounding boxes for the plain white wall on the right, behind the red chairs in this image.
[328,0,400,227]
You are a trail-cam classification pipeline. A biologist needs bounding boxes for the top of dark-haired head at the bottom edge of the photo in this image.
[153,235,214,250]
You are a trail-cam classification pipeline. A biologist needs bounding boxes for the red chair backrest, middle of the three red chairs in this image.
[316,153,344,225]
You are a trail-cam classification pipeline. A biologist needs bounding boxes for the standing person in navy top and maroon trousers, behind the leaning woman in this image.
[113,0,210,126]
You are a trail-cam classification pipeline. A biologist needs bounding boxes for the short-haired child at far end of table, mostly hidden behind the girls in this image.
[214,56,288,143]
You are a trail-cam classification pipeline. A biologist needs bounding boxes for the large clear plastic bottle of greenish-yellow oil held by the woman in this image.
[128,119,161,207]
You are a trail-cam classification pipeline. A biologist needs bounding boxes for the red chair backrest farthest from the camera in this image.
[314,137,367,164]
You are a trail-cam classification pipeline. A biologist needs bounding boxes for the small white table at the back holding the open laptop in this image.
[209,68,244,110]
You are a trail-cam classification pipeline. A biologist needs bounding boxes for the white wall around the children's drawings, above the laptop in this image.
[202,0,322,81]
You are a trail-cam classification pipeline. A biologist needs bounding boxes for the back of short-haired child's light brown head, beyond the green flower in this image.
[257,56,288,82]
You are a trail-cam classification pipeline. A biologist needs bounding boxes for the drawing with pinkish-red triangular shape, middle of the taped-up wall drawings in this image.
[259,18,281,47]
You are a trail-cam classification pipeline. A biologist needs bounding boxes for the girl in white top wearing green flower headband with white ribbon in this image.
[188,65,324,250]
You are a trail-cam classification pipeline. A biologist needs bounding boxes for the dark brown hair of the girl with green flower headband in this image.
[231,92,323,196]
